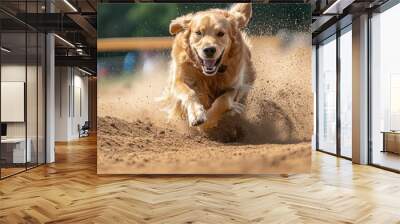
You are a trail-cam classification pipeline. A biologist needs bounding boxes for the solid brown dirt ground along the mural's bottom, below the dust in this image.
[98,117,311,174]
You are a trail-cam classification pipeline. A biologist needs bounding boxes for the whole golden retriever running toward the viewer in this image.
[162,3,255,130]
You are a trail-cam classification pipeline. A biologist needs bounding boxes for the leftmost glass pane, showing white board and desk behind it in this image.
[1,27,27,177]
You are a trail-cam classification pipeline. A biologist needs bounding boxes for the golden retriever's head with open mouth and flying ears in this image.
[169,3,252,76]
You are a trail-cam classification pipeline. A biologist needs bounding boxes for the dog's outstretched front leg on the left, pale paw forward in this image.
[175,81,207,127]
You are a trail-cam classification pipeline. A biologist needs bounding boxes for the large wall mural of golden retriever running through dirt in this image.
[97,3,313,174]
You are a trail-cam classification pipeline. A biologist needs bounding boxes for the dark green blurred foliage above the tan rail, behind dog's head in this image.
[97,3,311,38]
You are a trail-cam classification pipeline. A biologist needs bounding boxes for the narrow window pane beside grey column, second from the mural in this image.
[340,27,353,158]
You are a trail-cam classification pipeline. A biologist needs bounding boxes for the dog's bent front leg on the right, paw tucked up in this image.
[203,90,245,129]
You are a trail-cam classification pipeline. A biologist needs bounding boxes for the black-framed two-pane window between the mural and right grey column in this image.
[316,24,352,159]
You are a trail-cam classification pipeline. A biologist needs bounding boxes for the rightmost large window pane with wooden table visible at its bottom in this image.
[371,4,400,170]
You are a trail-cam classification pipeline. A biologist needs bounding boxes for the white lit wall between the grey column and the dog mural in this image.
[55,67,88,141]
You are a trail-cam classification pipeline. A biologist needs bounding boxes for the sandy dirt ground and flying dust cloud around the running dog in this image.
[98,34,313,174]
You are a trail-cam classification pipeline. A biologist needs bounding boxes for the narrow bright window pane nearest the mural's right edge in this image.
[318,36,336,153]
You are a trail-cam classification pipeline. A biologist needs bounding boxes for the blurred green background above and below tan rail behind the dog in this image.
[97,3,311,80]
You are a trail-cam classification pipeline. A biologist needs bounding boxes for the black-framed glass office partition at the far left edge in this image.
[0,1,46,179]
